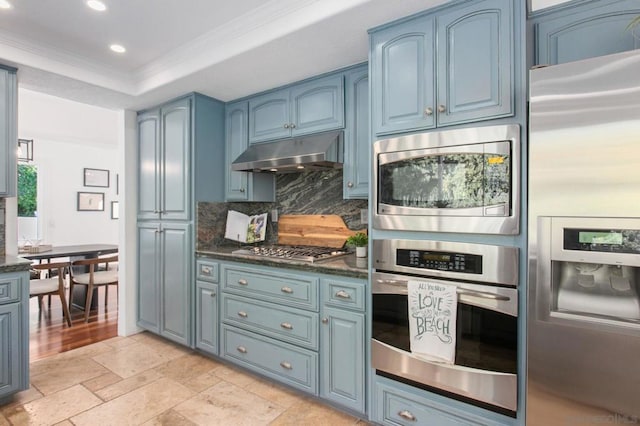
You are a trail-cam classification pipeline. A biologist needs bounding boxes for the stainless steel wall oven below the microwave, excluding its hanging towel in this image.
[371,240,518,416]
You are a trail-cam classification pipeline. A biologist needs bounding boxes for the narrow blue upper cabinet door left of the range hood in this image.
[225,102,249,201]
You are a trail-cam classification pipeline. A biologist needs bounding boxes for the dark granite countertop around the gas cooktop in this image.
[196,246,368,279]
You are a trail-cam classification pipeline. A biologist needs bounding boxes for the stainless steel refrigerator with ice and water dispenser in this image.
[526,51,640,426]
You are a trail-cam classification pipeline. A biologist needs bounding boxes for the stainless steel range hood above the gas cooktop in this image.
[231,130,344,173]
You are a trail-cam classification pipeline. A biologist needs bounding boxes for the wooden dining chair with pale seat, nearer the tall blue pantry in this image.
[69,254,118,322]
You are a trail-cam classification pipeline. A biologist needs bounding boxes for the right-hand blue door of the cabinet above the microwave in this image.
[436,0,514,126]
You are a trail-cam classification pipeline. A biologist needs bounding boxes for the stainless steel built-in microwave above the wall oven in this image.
[373,125,520,235]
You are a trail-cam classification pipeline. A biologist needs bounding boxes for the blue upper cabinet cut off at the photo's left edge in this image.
[0,68,18,197]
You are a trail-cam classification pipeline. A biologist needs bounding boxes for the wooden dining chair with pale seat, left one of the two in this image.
[29,262,71,327]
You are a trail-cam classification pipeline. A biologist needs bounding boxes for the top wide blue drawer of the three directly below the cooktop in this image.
[222,265,318,311]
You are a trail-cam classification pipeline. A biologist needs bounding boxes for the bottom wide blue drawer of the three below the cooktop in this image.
[222,325,318,395]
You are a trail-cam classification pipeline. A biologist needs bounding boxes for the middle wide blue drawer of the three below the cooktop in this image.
[222,294,318,349]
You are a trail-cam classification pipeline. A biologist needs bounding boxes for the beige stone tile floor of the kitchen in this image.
[0,333,367,426]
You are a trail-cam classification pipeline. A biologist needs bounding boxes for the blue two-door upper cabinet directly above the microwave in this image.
[370,0,514,135]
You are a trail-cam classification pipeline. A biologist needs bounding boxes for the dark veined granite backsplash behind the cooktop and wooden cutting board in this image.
[196,169,368,250]
